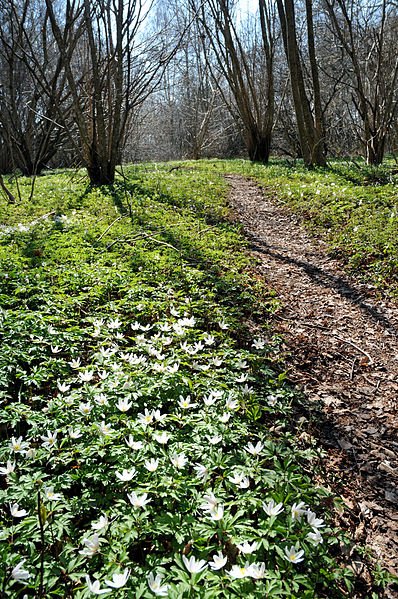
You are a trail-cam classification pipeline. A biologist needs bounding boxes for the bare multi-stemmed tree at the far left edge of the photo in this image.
[0,0,68,175]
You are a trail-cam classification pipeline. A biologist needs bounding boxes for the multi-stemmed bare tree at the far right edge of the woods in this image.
[325,0,398,164]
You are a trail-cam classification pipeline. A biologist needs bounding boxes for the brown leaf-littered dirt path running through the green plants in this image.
[227,175,398,584]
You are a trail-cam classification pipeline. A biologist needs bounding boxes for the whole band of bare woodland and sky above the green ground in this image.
[0,0,398,184]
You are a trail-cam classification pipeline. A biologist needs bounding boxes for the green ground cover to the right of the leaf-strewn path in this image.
[193,159,398,296]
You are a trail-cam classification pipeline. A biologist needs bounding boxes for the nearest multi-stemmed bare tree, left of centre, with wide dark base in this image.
[25,0,184,185]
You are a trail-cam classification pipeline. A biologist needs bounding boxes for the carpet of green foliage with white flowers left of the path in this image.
[0,165,377,599]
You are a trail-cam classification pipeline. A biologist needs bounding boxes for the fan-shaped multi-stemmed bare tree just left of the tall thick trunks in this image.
[194,0,275,163]
